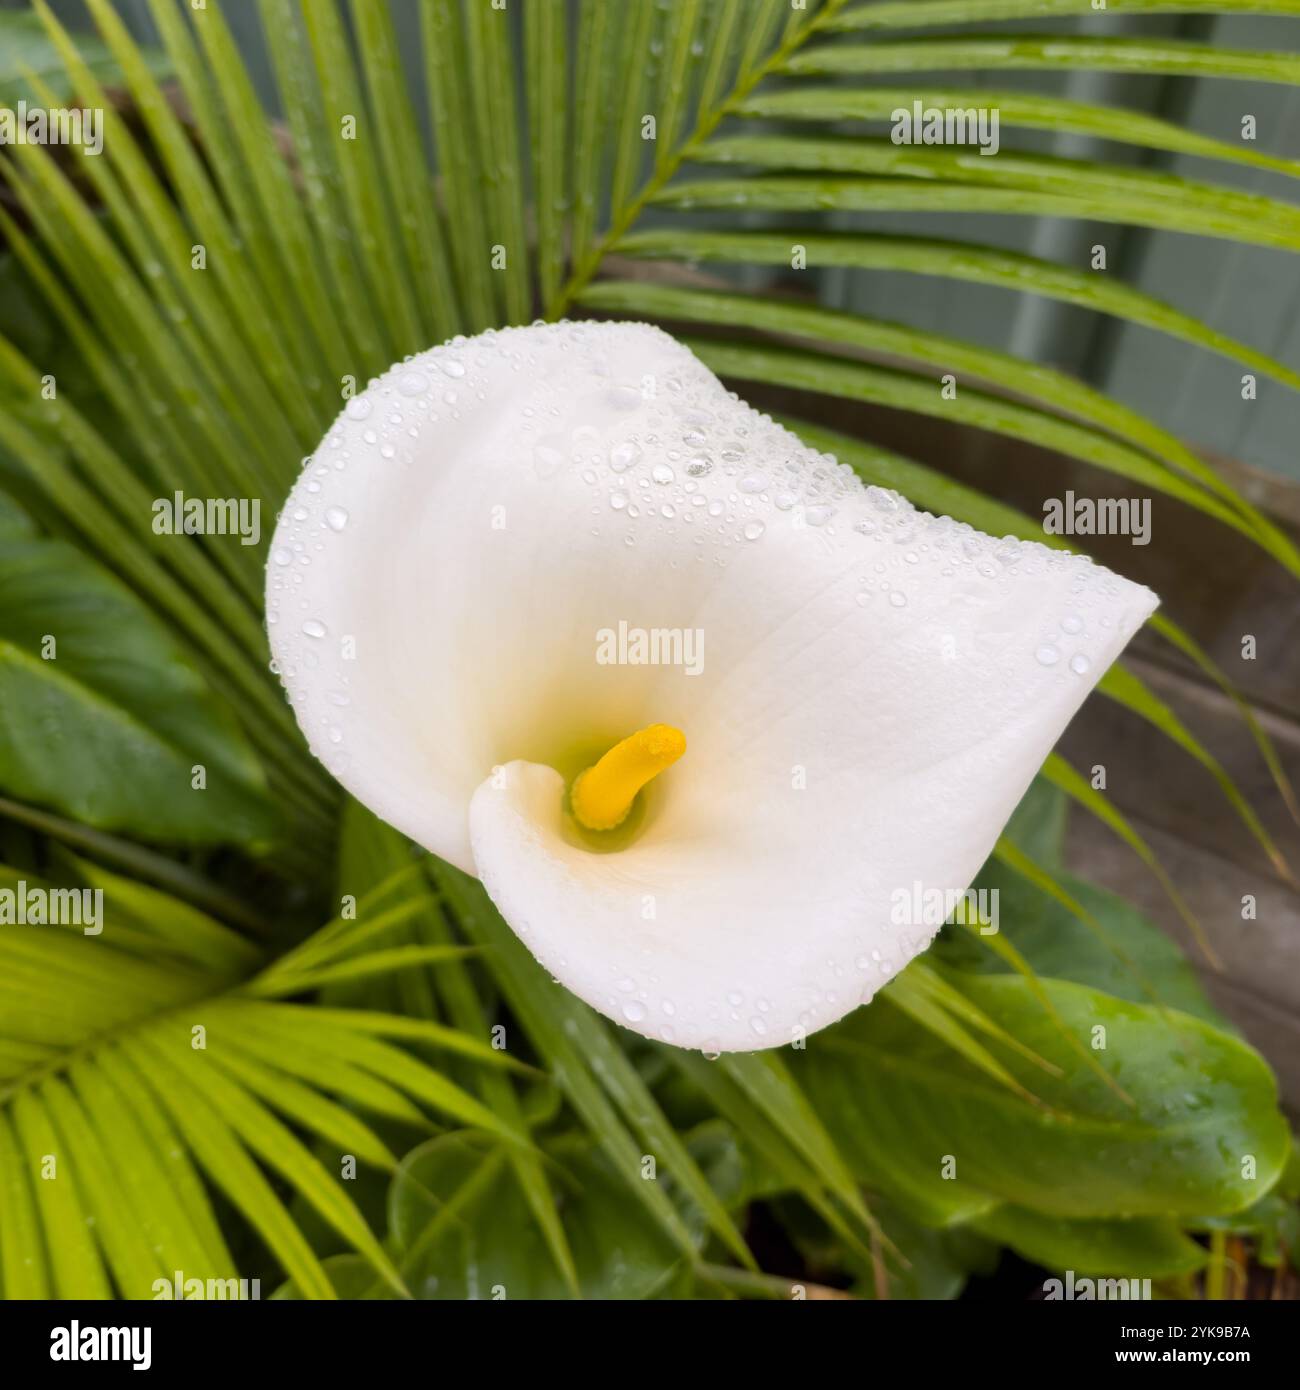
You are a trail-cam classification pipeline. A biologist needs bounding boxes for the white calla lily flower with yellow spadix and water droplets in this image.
[267,322,1157,1051]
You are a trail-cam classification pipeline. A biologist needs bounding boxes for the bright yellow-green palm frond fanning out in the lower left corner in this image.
[0,866,530,1298]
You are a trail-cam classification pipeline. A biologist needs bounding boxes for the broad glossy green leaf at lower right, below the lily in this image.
[793,974,1289,1218]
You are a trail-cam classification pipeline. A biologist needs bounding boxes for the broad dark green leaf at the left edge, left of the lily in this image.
[0,522,275,842]
